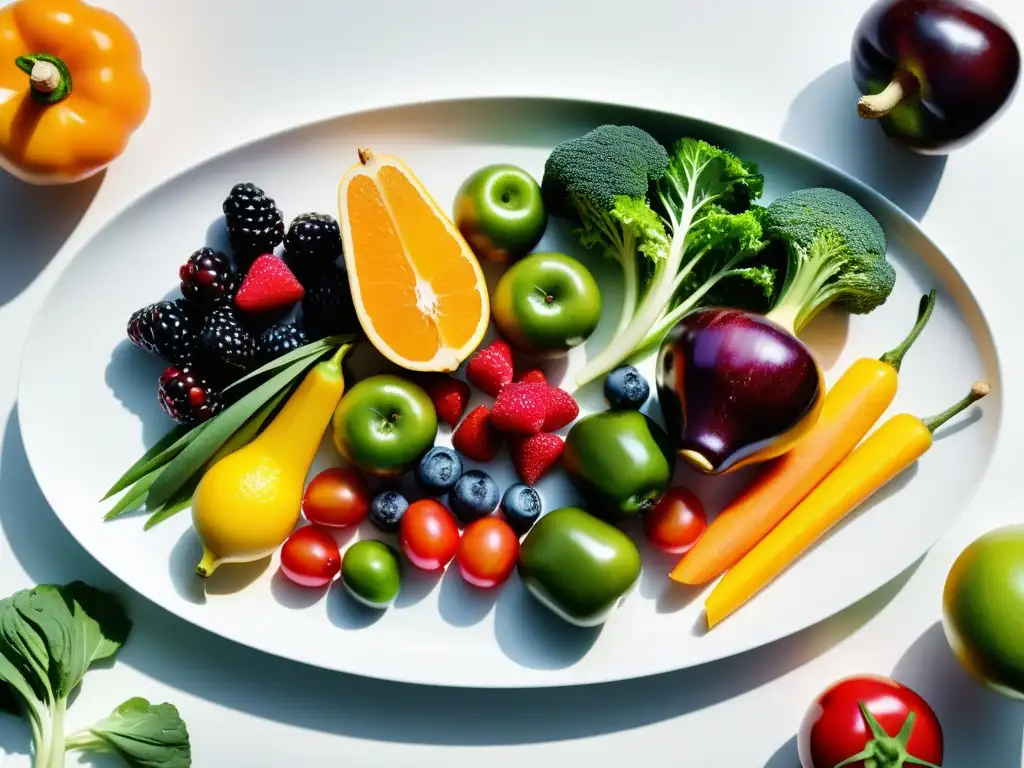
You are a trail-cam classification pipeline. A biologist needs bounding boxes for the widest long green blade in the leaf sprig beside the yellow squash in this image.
[146,350,326,507]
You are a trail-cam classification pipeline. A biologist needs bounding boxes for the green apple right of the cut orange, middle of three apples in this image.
[490,253,601,357]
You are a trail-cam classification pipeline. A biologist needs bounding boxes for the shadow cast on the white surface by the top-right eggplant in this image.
[780,61,946,219]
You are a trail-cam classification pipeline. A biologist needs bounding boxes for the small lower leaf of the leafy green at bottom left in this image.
[66,697,191,768]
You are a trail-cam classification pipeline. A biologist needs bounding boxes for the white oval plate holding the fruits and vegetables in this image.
[18,99,1000,687]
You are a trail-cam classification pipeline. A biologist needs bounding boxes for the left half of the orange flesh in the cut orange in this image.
[346,176,438,361]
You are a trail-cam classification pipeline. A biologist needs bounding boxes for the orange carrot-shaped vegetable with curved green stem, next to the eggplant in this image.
[669,291,935,585]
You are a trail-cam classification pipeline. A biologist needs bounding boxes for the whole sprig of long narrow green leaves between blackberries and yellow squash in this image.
[100,336,354,530]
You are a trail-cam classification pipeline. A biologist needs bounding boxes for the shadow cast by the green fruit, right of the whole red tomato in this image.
[891,623,1024,768]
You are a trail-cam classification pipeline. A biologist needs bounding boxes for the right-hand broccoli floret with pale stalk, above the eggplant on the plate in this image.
[765,187,896,333]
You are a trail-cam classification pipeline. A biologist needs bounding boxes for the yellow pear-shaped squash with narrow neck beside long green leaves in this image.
[193,345,348,578]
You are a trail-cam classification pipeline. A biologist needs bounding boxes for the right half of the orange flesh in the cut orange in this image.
[378,166,483,352]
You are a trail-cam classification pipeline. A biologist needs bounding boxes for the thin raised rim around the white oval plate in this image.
[14,93,1006,689]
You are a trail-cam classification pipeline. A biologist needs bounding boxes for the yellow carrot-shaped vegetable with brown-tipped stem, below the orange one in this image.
[705,382,991,628]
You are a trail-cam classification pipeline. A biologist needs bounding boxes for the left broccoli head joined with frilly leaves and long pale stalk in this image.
[542,126,774,387]
